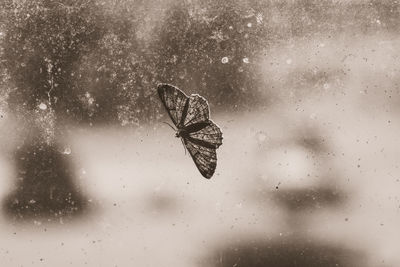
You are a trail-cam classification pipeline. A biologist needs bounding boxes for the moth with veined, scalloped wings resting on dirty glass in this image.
[157,84,222,179]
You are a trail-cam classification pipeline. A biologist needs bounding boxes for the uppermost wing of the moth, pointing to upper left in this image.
[157,84,189,127]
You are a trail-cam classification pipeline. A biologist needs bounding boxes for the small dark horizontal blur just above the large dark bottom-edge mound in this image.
[273,187,344,211]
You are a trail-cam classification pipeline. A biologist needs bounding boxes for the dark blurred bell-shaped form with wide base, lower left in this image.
[3,140,87,222]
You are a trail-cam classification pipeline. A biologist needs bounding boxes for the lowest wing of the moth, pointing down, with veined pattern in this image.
[184,139,217,179]
